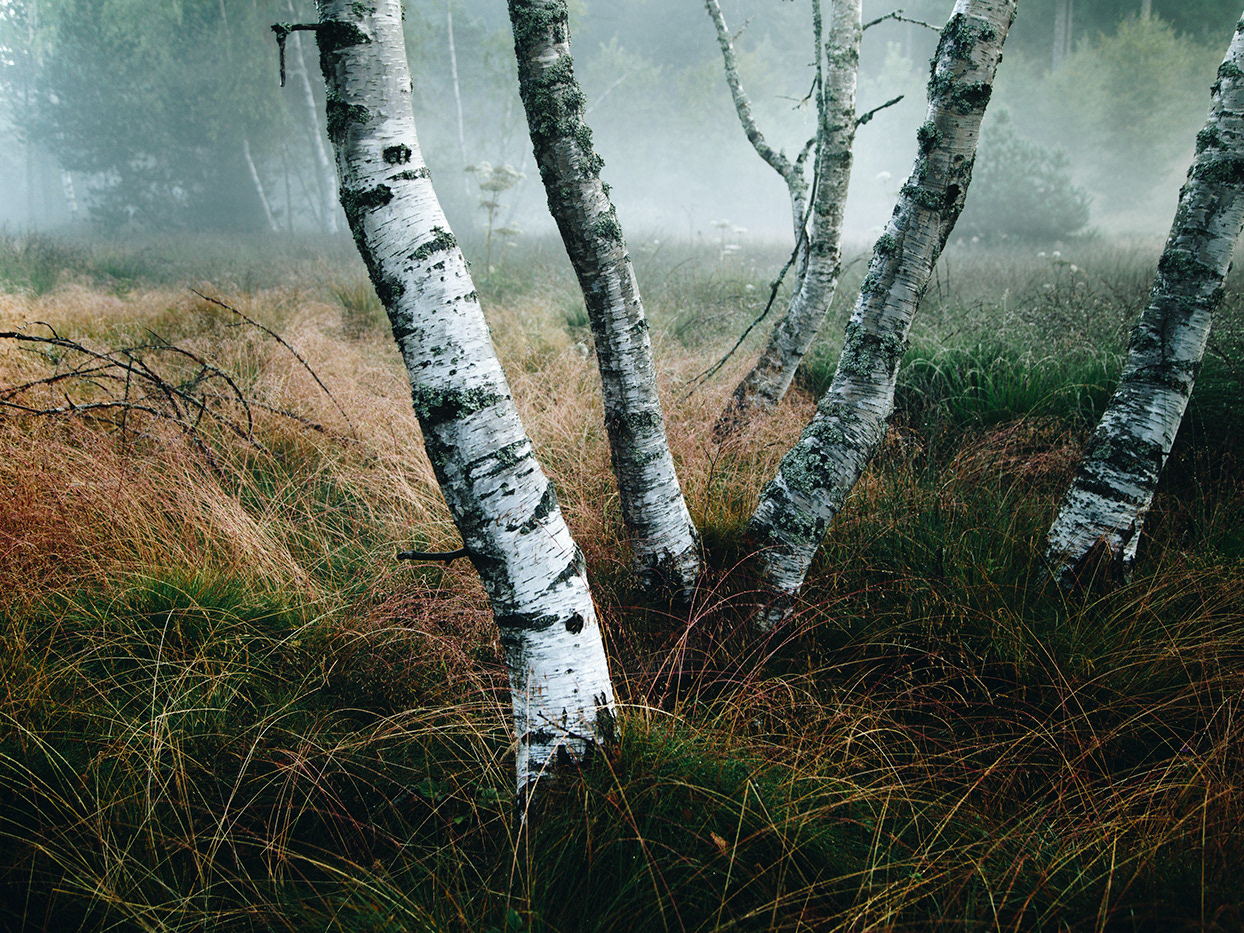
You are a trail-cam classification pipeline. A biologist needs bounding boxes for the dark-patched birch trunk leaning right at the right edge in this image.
[1047,18,1244,587]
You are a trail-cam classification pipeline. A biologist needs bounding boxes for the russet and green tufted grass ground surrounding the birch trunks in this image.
[0,228,1244,933]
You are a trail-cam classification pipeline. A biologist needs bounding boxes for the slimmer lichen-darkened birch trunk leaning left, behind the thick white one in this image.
[509,0,699,598]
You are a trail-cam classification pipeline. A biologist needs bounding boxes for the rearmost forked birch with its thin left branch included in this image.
[705,0,871,434]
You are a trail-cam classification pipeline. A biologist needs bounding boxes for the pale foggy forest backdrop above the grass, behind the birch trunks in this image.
[0,0,1239,249]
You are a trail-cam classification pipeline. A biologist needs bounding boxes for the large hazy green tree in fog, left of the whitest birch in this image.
[27,0,284,228]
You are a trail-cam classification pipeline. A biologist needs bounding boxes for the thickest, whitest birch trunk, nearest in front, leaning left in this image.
[316,0,613,796]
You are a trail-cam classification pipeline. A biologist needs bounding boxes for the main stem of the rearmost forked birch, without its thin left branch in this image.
[708,0,863,435]
